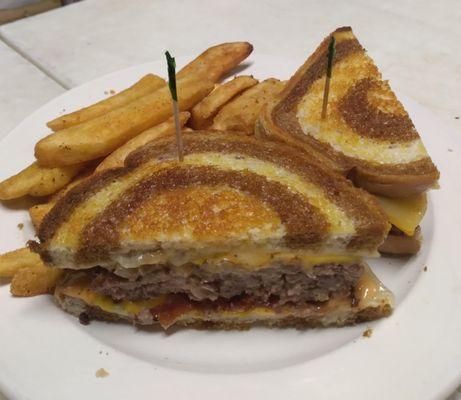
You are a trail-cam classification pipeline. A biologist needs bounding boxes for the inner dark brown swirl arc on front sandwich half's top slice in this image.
[77,166,327,263]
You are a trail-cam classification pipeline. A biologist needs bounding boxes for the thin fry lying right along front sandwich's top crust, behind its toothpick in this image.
[96,111,190,172]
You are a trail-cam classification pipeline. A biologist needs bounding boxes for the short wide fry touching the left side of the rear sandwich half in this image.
[212,78,284,134]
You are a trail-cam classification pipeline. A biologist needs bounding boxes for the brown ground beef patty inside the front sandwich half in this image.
[91,264,363,305]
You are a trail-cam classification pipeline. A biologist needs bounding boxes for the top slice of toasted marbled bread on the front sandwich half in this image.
[32,131,390,269]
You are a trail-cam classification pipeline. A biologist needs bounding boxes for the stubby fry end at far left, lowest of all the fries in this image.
[10,261,64,297]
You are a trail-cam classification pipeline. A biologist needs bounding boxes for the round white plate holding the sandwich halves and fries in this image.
[0,56,461,400]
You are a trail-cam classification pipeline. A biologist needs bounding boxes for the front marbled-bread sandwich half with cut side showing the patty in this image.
[30,131,393,329]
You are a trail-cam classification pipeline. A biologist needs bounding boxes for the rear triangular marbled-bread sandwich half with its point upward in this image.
[257,27,439,254]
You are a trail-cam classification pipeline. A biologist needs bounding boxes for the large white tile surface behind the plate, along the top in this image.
[0,0,461,127]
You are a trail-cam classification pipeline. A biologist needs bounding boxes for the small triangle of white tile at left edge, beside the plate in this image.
[0,41,65,139]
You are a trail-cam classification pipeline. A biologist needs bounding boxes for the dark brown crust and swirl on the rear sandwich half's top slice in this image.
[258,28,439,197]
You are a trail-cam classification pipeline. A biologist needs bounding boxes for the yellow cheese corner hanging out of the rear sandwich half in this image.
[376,193,427,236]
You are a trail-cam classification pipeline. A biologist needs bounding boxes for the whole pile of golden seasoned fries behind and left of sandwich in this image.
[0,42,284,296]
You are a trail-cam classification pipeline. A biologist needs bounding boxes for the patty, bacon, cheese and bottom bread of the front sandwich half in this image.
[56,263,393,328]
